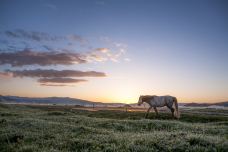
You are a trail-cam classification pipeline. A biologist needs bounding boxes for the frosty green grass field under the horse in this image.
[0,104,228,152]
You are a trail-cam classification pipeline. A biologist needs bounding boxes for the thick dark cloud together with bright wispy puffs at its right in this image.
[0,45,124,67]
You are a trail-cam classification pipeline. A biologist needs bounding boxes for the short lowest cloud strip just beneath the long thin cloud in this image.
[38,78,87,85]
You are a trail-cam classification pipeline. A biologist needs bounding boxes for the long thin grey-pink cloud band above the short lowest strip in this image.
[5,69,106,78]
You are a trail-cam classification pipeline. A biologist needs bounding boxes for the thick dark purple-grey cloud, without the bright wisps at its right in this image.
[0,50,87,67]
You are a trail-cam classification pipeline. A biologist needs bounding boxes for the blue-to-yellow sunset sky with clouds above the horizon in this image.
[0,0,228,103]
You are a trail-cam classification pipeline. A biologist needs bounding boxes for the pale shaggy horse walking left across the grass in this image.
[138,95,180,119]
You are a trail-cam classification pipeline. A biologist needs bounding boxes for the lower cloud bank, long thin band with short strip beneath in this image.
[0,69,106,86]
